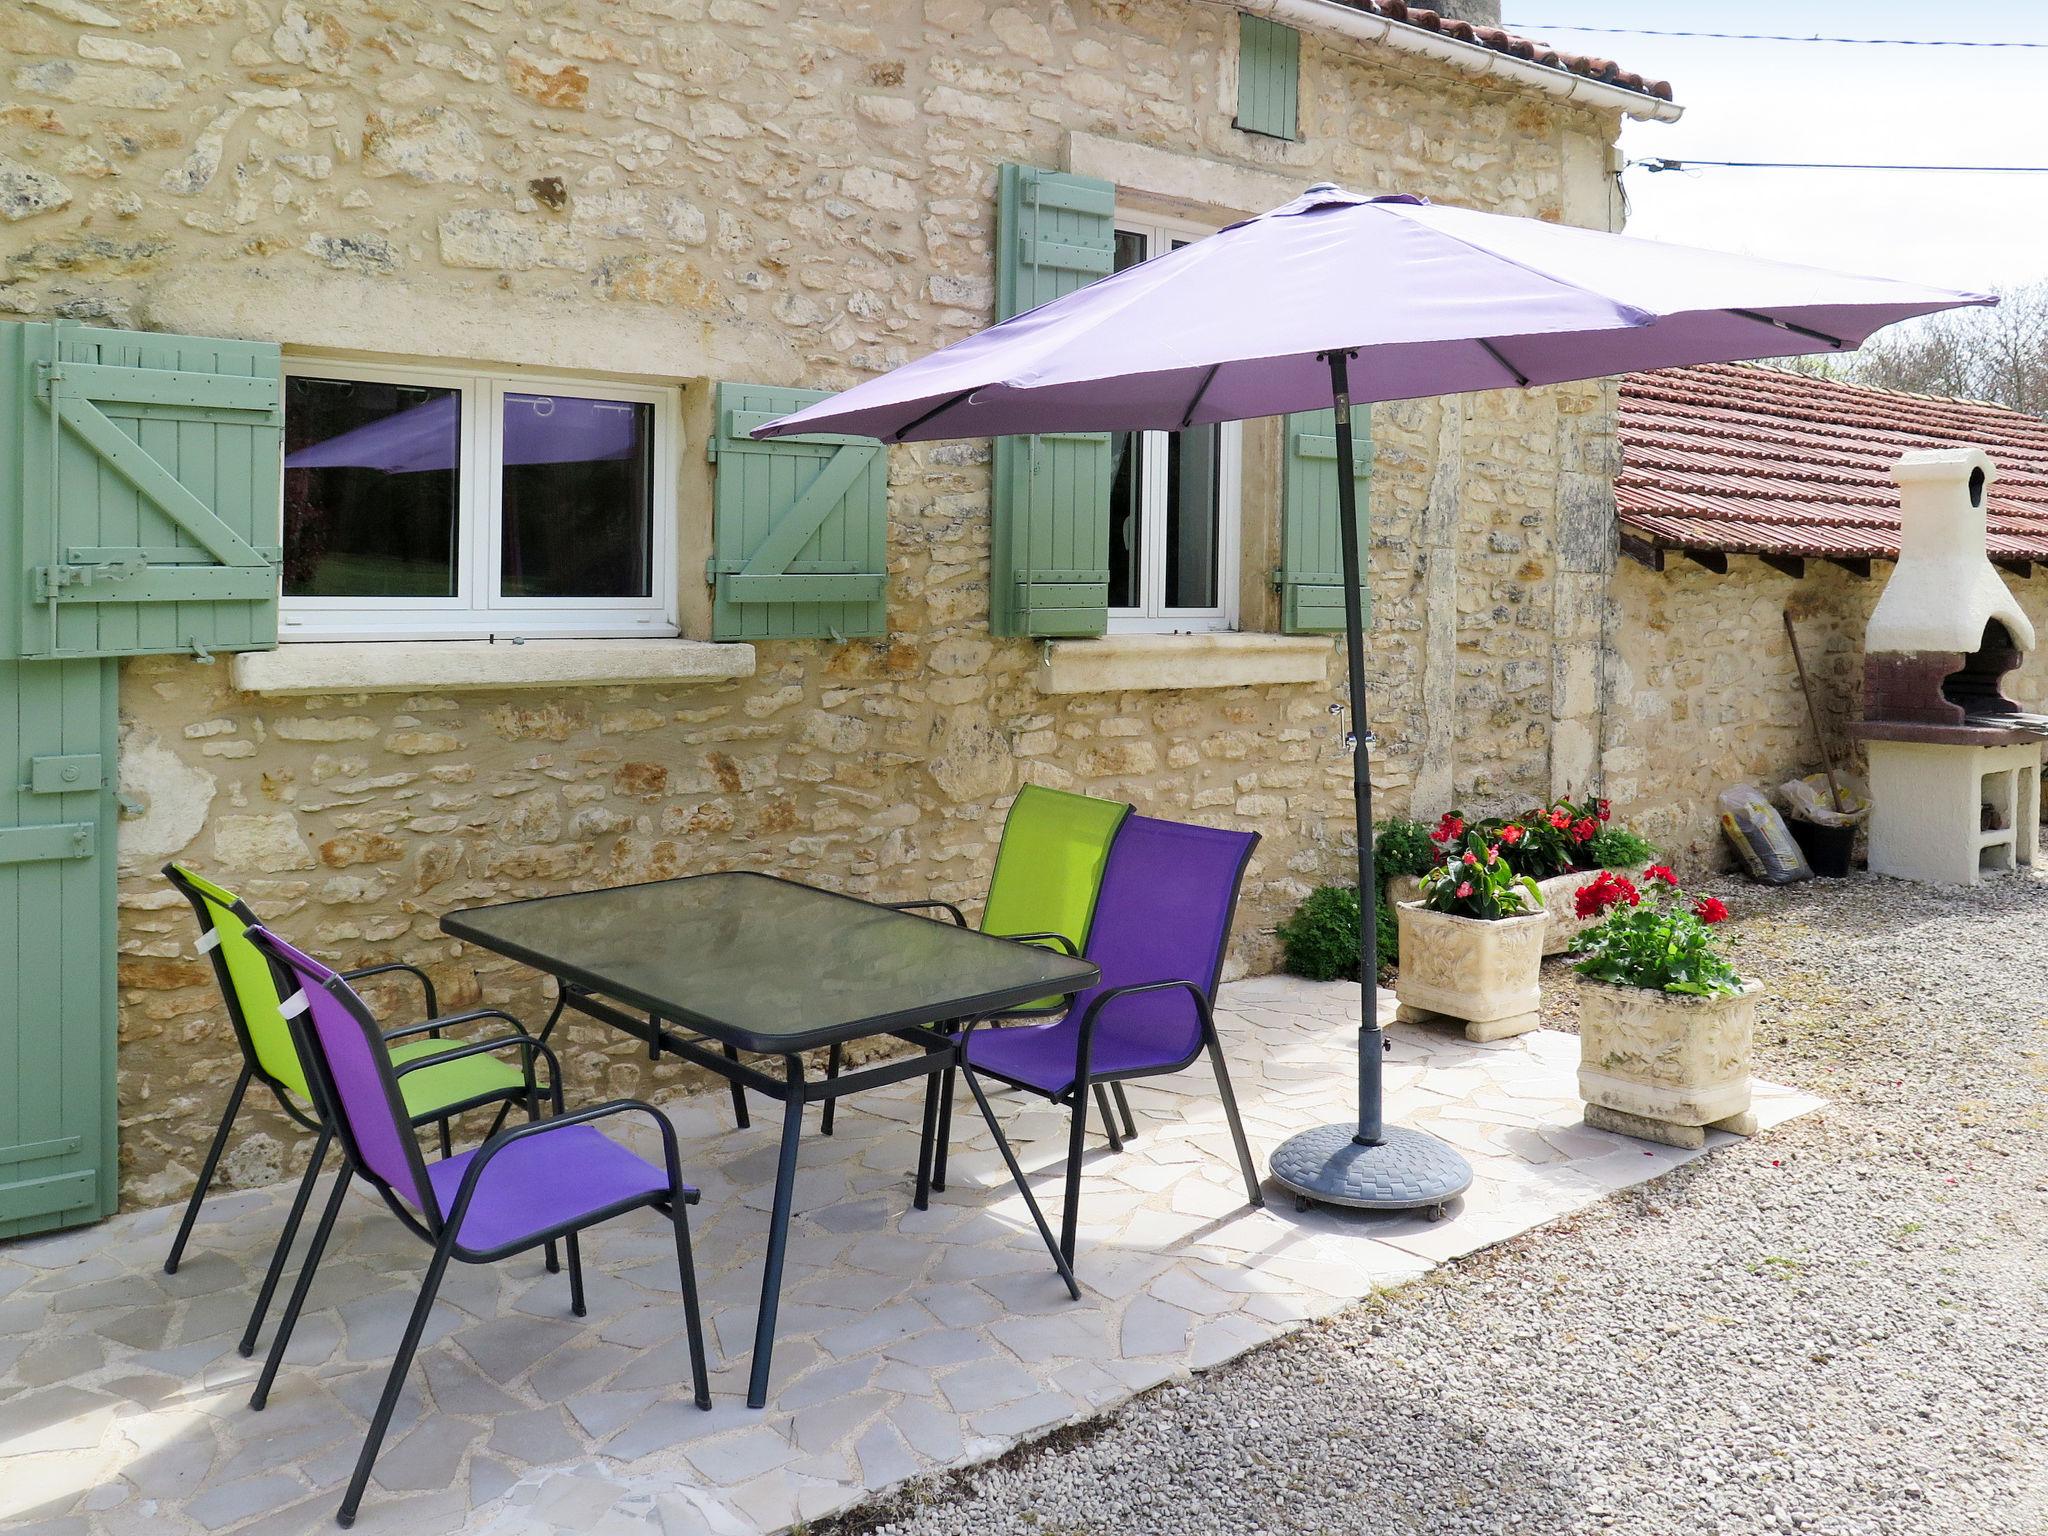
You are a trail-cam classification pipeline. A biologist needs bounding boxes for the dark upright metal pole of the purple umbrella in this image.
[1329,350,1384,1147]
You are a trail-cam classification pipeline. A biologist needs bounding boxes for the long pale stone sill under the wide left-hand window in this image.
[229,639,754,696]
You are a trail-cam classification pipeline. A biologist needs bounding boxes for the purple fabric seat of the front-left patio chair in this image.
[426,1124,679,1249]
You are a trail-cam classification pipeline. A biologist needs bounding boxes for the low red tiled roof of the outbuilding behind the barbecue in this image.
[1614,362,2048,563]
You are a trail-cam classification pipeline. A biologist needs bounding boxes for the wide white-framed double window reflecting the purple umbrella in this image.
[279,360,680,639]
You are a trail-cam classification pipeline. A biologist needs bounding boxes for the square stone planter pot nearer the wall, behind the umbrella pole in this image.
[1395,901,1546,1040]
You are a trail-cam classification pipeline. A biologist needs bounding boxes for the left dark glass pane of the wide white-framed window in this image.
[285,377,463,598]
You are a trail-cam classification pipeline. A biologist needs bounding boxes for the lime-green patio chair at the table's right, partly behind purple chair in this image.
[825,784,1137,1163]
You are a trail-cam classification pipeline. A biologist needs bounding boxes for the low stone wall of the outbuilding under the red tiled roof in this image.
[1604,553,2048,866]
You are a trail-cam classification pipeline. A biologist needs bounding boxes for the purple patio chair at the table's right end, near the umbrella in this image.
[926,815,1266,1264]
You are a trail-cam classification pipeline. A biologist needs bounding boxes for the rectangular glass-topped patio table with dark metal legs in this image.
[440,872,1096,1407]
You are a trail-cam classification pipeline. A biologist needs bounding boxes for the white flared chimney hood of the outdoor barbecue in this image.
[1864,449,2034,653]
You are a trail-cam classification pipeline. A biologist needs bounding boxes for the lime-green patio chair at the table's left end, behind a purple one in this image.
[164,864,557,1356]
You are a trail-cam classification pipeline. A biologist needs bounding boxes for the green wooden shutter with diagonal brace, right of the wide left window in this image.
[711,383,889,639]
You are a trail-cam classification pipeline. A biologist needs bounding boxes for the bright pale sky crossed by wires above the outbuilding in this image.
[1503,0,2048,289]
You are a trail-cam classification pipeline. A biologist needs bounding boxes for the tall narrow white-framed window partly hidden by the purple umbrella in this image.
[1110,219,1243,633]
